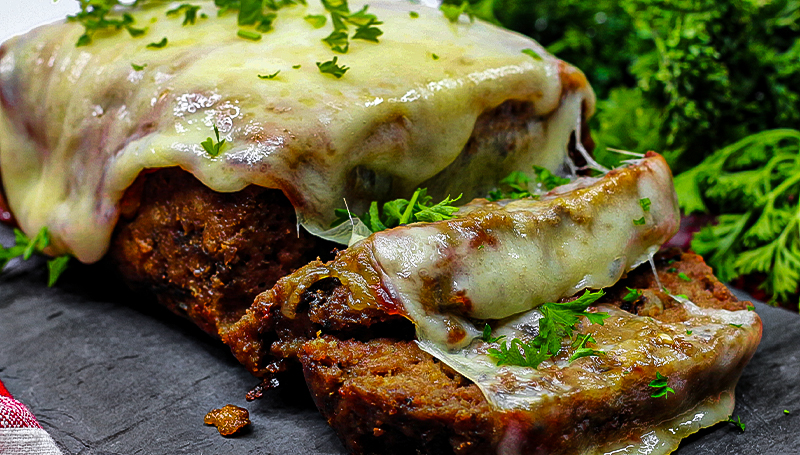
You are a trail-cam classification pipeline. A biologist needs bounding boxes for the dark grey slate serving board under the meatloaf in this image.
[0,230,800,455]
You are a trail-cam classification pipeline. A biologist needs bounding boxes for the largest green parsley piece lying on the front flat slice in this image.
[488,290,609,368]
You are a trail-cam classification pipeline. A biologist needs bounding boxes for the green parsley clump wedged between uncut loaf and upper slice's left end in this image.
[333,188,461,232]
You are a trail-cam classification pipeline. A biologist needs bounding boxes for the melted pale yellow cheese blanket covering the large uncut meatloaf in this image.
[0,0,594,262]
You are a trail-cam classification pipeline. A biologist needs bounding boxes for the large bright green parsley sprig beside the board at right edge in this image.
[675,130,800,302]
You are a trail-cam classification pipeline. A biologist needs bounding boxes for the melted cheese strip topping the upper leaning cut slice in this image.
[370,156,680,348]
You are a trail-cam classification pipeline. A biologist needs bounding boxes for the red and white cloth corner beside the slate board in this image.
[0,381,61,455]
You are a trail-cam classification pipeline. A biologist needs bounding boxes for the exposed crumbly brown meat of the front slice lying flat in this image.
[230,250,749,454]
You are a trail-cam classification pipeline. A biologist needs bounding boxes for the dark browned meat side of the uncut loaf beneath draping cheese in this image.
[110,168,333,336]
